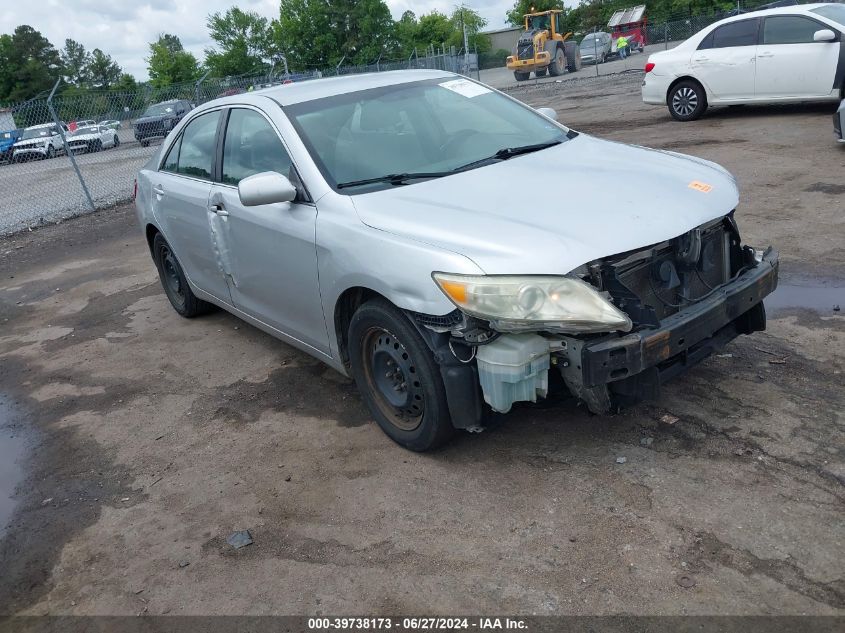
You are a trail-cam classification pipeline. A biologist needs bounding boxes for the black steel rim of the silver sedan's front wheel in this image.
[363,328,425,431]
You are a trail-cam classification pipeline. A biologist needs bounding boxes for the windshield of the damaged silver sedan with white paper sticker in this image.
[285,78,568,193]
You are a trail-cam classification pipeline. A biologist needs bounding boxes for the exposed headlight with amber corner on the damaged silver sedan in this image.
[432,273,631,332]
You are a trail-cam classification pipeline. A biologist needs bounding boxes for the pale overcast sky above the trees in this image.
[1,0,560,79]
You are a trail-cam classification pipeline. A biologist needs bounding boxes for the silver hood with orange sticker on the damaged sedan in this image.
[352,134,739,274]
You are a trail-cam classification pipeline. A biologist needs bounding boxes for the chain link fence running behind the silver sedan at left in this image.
[0,50,478,236]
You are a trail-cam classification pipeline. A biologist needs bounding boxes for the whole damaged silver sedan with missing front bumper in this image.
[136,71,778,451]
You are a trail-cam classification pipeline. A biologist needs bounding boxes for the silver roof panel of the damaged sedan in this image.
[201,70,464,109]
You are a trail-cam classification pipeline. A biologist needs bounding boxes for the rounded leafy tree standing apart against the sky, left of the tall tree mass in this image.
[205,7,273,77]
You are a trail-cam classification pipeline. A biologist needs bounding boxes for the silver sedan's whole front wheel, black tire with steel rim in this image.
[349,299,455,452]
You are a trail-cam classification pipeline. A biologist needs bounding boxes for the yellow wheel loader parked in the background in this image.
[507,9,581,81]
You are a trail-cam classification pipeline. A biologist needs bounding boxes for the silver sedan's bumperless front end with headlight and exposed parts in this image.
[413,213,778,430]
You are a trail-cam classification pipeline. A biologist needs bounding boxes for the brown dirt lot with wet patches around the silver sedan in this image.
[0,76,845,614]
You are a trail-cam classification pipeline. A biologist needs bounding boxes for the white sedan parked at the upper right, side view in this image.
[642,4,845,121]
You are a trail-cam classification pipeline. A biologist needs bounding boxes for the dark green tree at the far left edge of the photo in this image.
[0,24,61,103]
